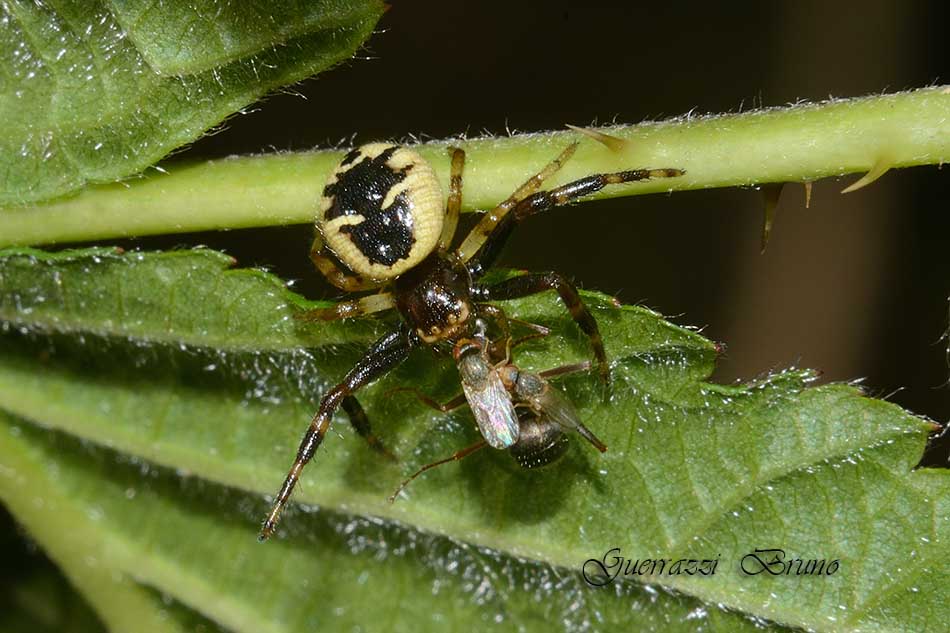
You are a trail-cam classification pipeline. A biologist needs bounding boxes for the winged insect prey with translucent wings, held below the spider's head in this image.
[389,319,607,503]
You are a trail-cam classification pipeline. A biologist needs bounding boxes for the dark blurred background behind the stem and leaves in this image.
[158,0,950,464]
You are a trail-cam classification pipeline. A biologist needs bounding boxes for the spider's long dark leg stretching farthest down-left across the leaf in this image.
[258,326,413,541]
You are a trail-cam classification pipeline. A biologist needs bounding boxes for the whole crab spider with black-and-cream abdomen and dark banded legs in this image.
[259,142,683,541]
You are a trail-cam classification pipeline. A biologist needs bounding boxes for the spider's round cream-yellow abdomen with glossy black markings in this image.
[316,143,445,280]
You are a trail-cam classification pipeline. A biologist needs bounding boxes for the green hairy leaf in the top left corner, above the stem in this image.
[0,0,383,205]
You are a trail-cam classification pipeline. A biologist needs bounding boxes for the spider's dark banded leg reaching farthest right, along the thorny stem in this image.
[459,168,685,277]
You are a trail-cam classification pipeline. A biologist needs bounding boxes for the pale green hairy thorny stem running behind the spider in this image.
[0,86,950,246]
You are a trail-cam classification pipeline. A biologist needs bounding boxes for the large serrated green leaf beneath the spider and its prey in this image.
[0,250,950,631]
